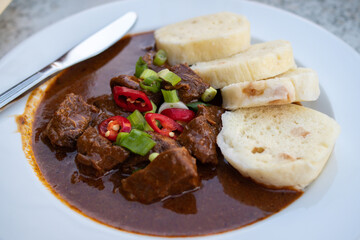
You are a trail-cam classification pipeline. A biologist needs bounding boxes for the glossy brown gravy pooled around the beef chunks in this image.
[31,33,302,236]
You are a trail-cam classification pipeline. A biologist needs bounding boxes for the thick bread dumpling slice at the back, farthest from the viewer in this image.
[155,12,250,65]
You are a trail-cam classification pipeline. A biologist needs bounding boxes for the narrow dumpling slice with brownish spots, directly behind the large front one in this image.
[221,68,320,110]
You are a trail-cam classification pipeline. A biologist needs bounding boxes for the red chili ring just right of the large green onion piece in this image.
[145,113,184,139]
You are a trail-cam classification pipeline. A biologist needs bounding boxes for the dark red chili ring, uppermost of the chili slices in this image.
[113,86,153,112]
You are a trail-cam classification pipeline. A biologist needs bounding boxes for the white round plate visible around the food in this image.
[0,0,360,240]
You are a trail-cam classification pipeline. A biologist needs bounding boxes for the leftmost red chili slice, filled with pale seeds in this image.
[98,116,131,141]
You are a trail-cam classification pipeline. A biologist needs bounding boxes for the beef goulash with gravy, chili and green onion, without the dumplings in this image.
[33,32,302,236]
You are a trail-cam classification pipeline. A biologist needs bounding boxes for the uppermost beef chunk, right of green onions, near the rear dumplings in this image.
[164,64,210,103]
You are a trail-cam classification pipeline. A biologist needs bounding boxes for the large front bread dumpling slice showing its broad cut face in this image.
[217,104,340,190]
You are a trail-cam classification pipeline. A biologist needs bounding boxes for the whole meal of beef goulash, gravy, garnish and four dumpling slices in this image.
[22,12,340,236]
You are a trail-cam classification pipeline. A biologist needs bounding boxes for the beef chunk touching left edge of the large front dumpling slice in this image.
[177,116,218,164]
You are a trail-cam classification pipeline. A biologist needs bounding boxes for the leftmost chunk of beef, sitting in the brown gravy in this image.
[44,93,99,148]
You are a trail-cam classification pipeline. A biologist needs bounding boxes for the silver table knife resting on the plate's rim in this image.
[0,12,137,109]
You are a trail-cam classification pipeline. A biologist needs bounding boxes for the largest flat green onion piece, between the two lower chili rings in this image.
[120,129,156,156]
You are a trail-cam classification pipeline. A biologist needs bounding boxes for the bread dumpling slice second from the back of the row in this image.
[191,40,295,89]
